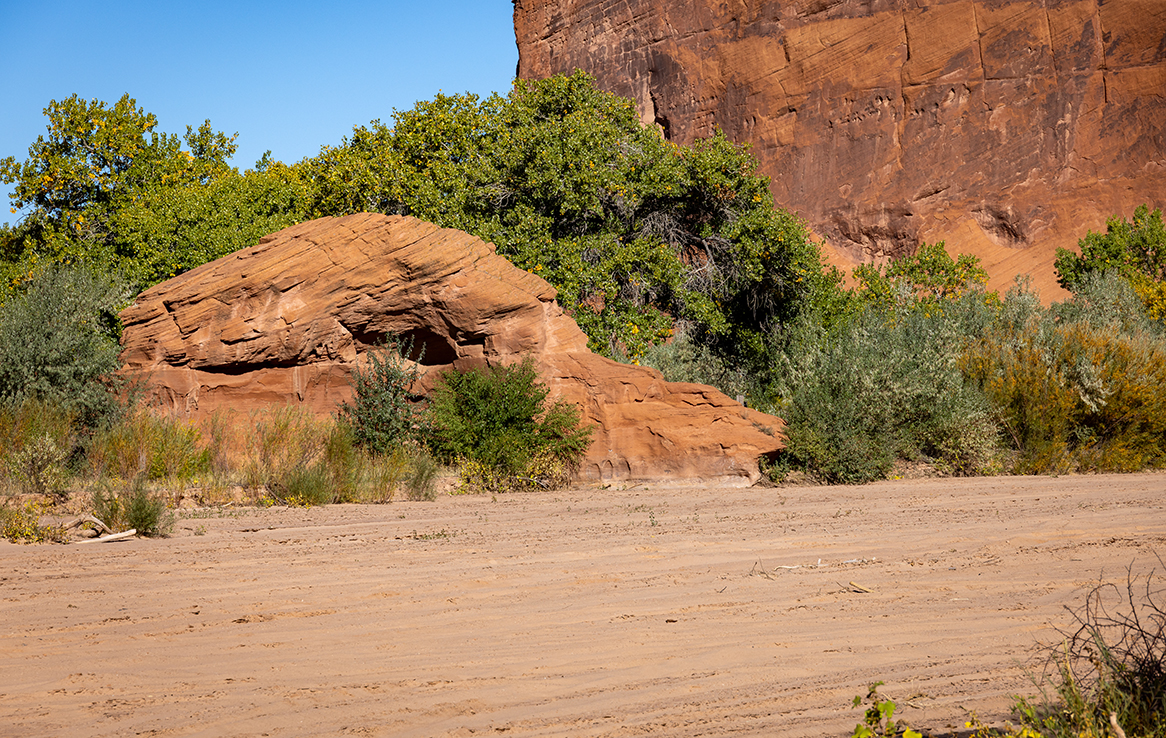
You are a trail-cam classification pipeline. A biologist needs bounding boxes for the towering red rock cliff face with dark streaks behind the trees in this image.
[514,0,1166,300]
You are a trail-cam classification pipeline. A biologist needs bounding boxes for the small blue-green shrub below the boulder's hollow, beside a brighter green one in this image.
[337,338,428,454]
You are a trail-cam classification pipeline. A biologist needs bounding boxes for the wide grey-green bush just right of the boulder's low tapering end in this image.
[771,294,999,484]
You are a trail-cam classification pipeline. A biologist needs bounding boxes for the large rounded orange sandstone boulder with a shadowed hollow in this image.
[121,213,782,483]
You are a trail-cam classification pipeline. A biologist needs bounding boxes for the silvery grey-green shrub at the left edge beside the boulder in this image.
[0,266,128,428]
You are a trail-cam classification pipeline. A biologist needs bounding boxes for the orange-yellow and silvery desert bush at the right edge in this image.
[962,280,1166,473]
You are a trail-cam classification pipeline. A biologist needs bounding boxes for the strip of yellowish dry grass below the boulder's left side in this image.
[0,401,440,542]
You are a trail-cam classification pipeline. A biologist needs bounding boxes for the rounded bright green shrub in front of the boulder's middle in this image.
[430,358,591,487]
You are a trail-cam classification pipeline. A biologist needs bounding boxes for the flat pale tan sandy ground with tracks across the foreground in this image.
[0,475,1166,737]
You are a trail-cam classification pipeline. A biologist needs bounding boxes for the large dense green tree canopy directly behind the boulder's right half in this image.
[301,72,833,358]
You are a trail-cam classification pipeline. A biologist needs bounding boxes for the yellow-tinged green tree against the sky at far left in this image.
[0,94,302,288]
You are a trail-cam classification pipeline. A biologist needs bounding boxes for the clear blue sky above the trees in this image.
[0,0,518,225]
